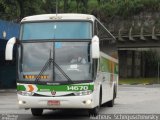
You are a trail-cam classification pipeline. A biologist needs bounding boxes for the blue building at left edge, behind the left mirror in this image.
[0,20,20,88]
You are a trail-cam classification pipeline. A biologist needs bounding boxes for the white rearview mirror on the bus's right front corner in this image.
[91,35,100,59]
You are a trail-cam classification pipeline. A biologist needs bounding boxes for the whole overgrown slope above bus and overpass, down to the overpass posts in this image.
[0,0,160,34]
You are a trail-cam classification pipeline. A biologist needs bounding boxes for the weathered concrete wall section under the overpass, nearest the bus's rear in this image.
[118,50,141,78]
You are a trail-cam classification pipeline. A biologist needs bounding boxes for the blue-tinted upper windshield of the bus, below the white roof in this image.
[20,21,92,40]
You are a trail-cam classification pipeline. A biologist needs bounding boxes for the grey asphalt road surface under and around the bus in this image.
[0,85,160,120]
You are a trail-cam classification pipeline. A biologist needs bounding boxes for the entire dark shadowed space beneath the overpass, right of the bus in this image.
[119,48,160,78]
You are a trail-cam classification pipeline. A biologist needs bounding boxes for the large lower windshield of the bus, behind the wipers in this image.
[19,42,92,82]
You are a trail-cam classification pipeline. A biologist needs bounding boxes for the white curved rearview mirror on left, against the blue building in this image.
[5,37,16,60]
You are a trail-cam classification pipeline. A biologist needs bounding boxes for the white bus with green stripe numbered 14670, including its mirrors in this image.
[5,14,118,116]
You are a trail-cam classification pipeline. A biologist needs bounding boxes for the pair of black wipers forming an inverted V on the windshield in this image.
[35,50,74,83]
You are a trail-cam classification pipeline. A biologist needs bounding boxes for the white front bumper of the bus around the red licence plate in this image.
[18,94,96,109]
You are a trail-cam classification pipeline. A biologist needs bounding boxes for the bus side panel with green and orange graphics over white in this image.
[100,53,118,103]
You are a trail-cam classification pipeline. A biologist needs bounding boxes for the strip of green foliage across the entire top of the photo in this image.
[0,0,160,21]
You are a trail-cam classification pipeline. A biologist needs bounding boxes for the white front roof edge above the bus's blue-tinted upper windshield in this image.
[21,13,96,22]
